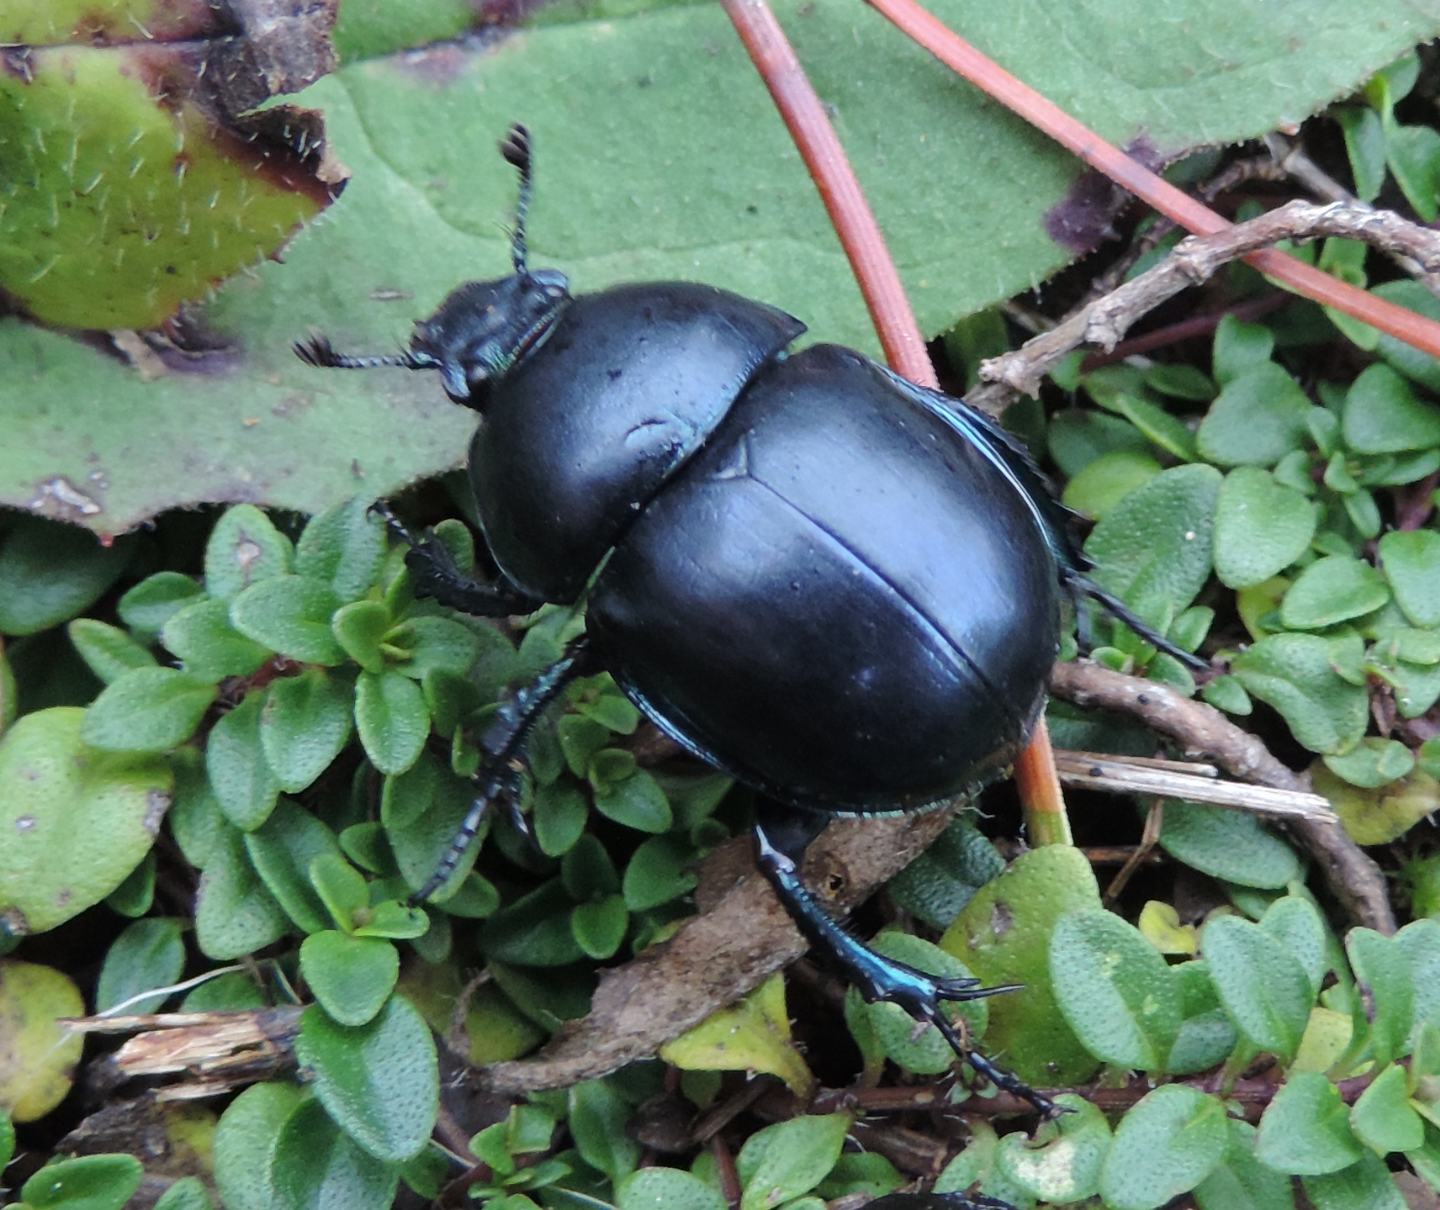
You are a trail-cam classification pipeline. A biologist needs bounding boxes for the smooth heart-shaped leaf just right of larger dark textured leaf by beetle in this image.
[1215,467,1315,588]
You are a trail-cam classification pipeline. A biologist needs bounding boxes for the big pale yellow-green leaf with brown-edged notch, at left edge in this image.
[0,706,173,936]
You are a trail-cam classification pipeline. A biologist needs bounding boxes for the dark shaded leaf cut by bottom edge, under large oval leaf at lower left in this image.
[266,1092,400,1210]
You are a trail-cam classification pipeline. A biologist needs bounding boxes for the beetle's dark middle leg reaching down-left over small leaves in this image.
[410,635,595,903]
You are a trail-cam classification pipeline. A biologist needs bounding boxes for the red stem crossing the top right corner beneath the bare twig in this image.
[865,0,1440,357]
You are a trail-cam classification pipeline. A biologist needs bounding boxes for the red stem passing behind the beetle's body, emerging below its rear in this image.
[724,0,1070,838]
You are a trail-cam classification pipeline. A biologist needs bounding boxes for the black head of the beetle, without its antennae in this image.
[409,269,570,408]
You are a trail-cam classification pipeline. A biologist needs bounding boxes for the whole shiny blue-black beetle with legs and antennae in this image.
[295,125,1197,1115]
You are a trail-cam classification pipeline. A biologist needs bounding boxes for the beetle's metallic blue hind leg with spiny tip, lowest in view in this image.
[755,814,1064,1118]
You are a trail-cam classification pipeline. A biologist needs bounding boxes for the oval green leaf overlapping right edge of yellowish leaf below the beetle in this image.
[1050,909,1181,1072]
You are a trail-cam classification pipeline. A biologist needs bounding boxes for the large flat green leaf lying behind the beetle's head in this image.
[0,0,1440,533]
